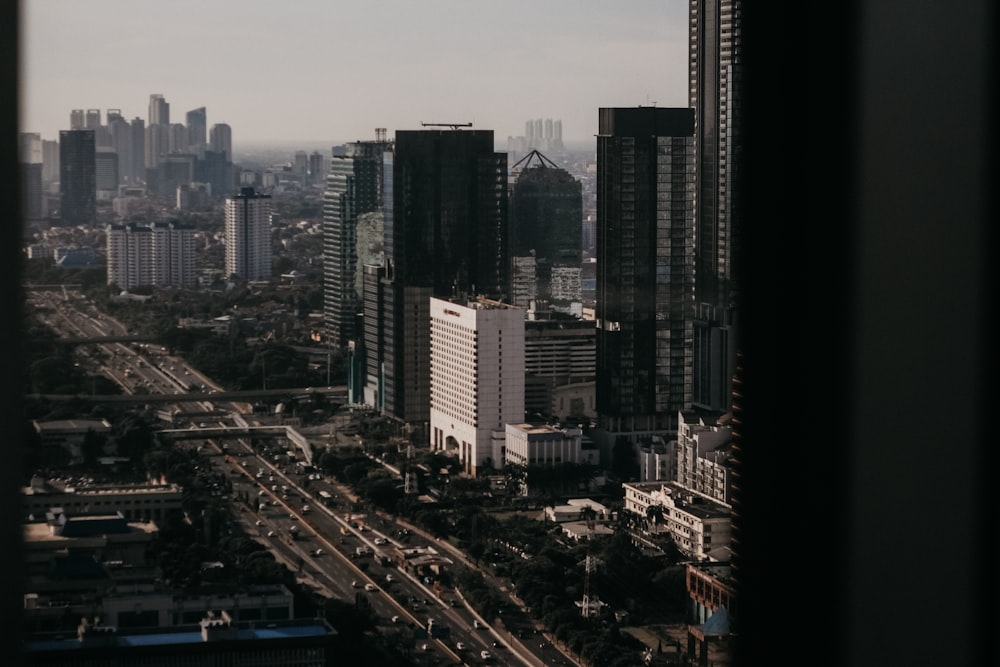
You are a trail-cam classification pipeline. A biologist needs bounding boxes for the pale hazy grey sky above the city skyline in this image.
[20,0,688,146]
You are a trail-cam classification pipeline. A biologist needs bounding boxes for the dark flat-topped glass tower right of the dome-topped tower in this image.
[596,107,695,440]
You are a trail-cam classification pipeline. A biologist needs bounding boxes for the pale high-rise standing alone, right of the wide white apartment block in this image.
[226,188,271,280]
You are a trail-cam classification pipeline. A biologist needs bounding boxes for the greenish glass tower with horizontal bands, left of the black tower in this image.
[322,135,392,347]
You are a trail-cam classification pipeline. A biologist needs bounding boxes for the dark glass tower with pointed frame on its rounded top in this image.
[510,151,583,313]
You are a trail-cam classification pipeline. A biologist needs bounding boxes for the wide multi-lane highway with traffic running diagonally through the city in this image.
[29,291,564,666]
